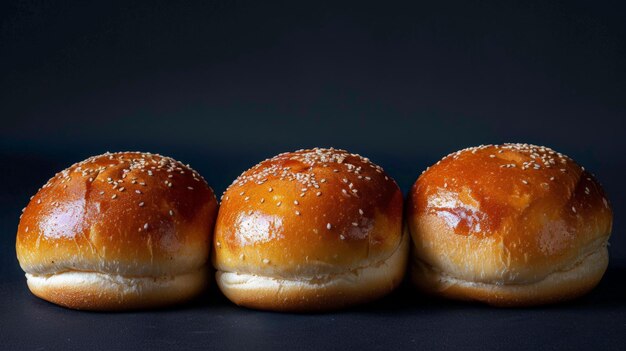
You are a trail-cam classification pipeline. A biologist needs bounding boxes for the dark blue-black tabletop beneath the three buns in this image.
[0,269,626,350]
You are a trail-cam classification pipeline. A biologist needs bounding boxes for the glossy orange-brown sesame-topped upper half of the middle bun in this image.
[214,148,403,278]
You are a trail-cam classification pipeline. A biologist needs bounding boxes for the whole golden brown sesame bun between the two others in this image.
[213,149,408,311]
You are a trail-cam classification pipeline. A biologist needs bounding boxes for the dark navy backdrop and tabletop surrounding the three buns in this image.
[0,1,626,349]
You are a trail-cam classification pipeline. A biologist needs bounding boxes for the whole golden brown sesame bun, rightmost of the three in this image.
[407,144,613,306]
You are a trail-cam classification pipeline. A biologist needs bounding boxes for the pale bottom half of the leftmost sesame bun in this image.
[26,268,210,311]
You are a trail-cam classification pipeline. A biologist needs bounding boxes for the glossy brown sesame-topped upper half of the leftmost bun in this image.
[16,152,217,277]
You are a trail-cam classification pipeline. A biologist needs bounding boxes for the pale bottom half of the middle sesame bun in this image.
[216,232,409,312]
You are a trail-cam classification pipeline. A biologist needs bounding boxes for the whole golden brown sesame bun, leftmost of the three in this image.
[16,152,217,310]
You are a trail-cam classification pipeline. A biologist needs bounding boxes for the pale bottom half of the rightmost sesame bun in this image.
[410,245,609,307]
